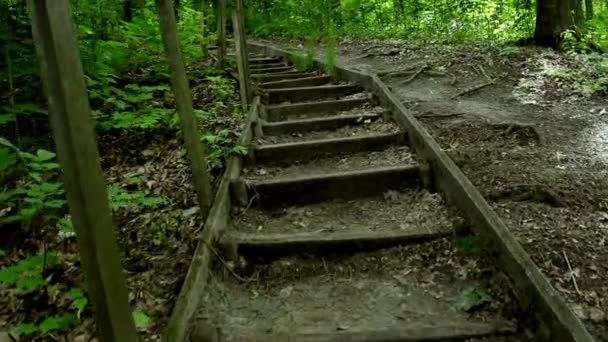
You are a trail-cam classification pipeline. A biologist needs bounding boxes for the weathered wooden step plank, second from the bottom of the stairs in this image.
[220,228,446,258]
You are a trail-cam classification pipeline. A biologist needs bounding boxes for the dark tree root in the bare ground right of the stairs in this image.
[488,184,568,208]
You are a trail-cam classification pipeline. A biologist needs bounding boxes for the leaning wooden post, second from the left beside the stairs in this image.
[156,0,213,220]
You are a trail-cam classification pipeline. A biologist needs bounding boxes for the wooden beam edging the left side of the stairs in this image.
[163,96,260,342]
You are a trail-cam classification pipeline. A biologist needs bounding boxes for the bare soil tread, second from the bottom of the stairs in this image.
[232,189,452,234]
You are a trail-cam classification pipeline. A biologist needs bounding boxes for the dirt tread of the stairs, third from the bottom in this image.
[242,146,417,181]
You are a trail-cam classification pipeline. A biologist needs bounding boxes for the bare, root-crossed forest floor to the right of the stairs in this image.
[258,39,608,341]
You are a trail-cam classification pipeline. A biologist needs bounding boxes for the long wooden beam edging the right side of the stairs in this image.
[249,42,594,342]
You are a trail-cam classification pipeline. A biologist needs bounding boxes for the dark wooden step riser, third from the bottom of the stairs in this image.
[230,165,425,207]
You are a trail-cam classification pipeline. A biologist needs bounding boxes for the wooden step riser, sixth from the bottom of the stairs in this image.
[264,96,372,121]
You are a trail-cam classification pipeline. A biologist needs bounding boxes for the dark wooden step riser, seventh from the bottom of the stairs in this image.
[265,84,363,104]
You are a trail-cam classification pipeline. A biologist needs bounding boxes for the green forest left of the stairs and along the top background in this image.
[0,0,608,338]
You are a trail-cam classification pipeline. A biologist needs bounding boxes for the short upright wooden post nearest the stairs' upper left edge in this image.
[232,0,253,112]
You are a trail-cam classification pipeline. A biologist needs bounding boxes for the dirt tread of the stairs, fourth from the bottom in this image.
[257,114,401,145]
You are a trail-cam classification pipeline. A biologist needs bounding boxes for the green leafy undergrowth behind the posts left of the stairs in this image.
[0,0,240,340]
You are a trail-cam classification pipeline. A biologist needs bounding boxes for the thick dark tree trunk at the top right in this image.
[534,0,576,47]
